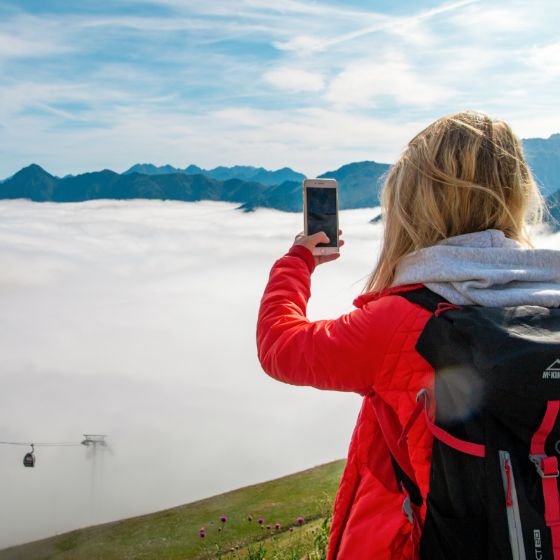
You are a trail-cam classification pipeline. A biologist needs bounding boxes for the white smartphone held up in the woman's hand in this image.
[303,179,339,255]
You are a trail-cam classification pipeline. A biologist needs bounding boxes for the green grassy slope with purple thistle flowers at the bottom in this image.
[0,460,344,560]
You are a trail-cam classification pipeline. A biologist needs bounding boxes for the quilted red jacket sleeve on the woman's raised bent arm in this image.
[257,246,408,395]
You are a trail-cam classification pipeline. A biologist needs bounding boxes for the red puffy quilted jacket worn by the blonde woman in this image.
[257,245,434,560]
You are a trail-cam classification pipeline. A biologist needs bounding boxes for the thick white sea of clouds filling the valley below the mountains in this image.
[0,200,560,546]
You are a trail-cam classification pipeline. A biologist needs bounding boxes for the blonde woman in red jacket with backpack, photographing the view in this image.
[256,111,560,560]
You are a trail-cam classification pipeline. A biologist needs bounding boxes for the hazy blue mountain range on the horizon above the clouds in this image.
[0,134,560,229]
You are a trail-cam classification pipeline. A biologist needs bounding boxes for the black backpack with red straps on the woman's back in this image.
[395,288,560,560]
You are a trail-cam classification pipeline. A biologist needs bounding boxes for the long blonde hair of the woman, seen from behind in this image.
[363,111,544,293]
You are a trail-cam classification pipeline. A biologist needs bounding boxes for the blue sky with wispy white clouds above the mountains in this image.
[0,0,560,177]
